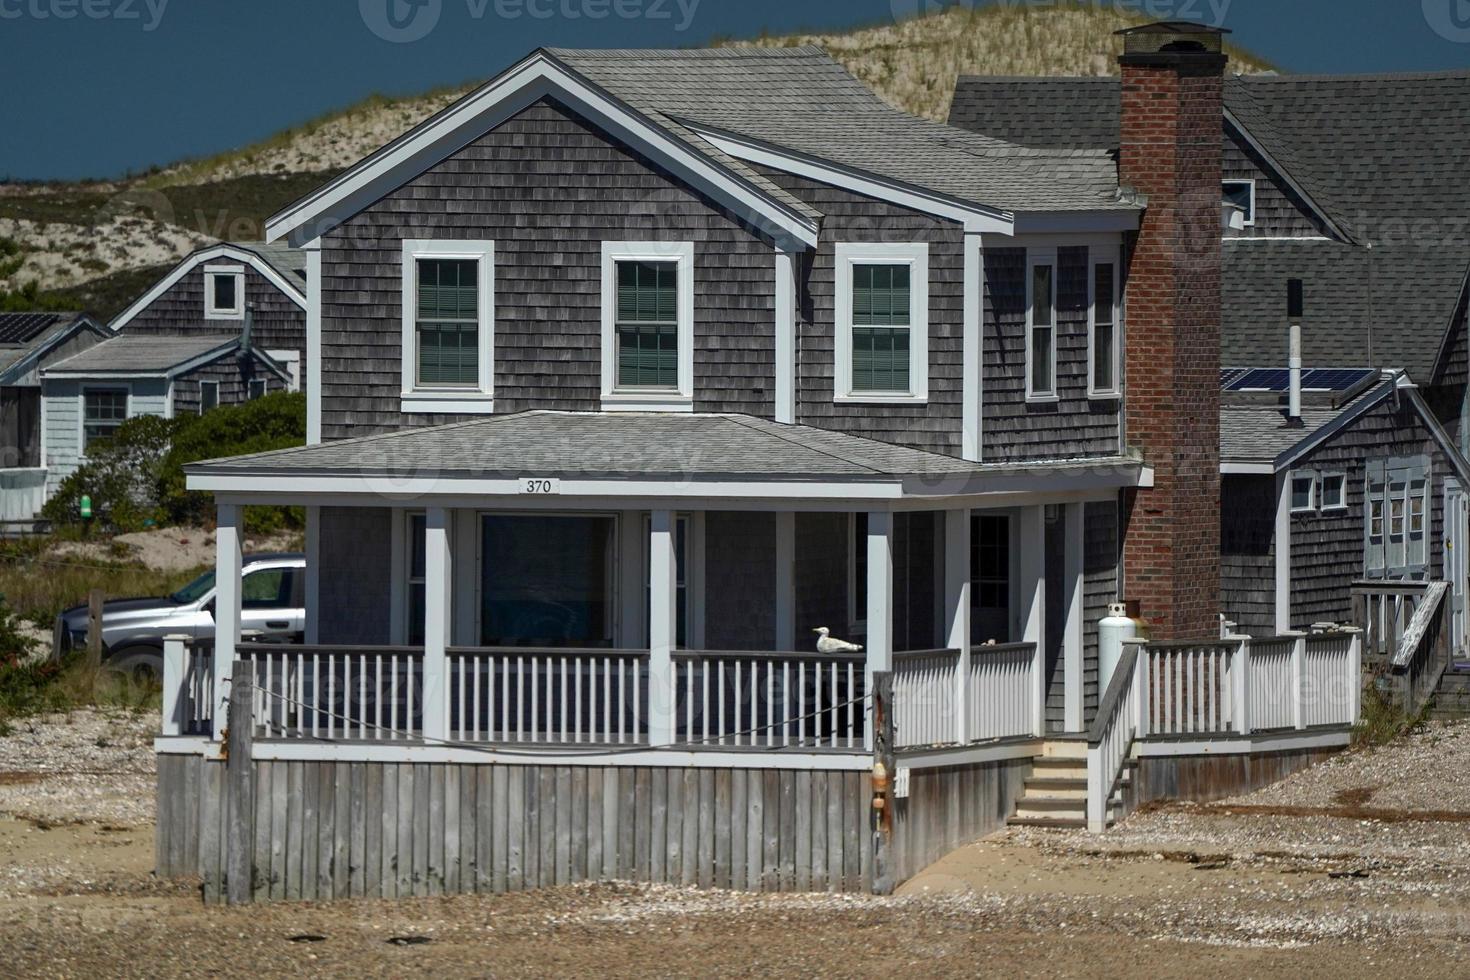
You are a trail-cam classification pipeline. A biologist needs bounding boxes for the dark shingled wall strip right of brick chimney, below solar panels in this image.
[1220,475,1275,636]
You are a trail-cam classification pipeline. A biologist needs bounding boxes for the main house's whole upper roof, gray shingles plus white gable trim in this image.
[268,47,1139,245]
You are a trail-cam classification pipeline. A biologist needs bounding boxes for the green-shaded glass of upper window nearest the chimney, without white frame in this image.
[853,264,913,392]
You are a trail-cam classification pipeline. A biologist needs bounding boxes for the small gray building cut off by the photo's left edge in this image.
[0,311,109,520]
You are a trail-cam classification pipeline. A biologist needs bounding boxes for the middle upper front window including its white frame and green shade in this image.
[601,241,694,411]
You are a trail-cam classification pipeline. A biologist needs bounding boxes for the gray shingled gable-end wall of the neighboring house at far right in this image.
[1291,400,1451,629]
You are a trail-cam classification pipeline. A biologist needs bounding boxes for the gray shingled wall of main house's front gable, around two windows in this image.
[322,100,775,439]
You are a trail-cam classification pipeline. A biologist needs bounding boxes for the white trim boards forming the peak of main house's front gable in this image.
[266,51,817,247]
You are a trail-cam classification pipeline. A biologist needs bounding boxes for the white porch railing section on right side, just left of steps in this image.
[894,644,1045,749]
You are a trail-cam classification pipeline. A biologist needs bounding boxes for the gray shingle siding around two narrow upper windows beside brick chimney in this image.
[982,247,1122,463]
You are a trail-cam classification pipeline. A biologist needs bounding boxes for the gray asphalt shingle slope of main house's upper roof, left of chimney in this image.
[548,47,1136,212]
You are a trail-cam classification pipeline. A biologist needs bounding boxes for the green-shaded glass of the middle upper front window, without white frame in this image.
[613,262,679,391]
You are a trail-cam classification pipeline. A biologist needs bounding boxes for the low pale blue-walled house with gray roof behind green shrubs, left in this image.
[40,334,291,497]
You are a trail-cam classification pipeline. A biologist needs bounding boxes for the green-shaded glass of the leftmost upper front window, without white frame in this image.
[416,259,481,388]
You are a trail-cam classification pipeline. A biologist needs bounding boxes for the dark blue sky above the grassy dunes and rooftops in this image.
[0,0,1470,178]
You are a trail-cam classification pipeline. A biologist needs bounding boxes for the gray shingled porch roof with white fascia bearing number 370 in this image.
[185,411,1142,495]
